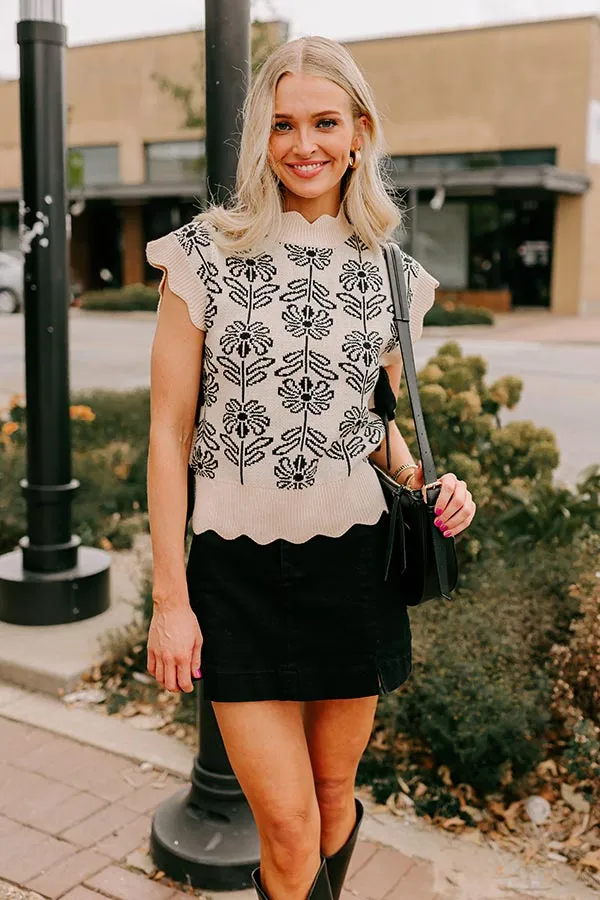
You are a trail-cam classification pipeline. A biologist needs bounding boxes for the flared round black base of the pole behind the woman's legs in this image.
[150,764,260,891]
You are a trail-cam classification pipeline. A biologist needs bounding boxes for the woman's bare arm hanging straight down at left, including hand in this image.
[148,281,204,691]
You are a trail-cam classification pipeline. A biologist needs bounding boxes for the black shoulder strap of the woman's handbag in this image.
[382,241,437,484]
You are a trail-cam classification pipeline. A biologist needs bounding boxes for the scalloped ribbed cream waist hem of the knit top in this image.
[192,462,387,544]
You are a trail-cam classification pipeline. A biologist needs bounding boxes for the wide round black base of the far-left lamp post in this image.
[0,547,110,625]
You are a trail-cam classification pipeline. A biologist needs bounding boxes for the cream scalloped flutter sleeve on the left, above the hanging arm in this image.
[146,222,210,331]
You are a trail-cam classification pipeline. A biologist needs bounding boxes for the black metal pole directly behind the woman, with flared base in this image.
[151,0,260,891]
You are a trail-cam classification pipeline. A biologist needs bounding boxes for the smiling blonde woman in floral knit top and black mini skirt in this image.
[148,38,475,900]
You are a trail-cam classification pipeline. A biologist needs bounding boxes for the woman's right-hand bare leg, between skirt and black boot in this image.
[304,696,377,856]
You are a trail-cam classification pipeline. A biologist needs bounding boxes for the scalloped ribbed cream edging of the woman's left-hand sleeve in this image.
[146,232,206,331]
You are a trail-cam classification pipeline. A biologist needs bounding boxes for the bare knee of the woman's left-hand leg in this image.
[259,803,321,873]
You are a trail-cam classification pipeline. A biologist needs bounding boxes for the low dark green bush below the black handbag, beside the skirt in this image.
[360,544,577,800]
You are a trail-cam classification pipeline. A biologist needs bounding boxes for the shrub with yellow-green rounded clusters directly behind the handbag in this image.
[396,342,600,561]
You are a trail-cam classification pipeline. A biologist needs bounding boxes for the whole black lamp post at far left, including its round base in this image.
[0,0,110,625]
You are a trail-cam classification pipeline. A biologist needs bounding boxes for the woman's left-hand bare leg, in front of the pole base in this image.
[213,700,321,900]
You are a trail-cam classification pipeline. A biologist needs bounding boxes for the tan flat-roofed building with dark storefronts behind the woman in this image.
[0,16,600,314]
